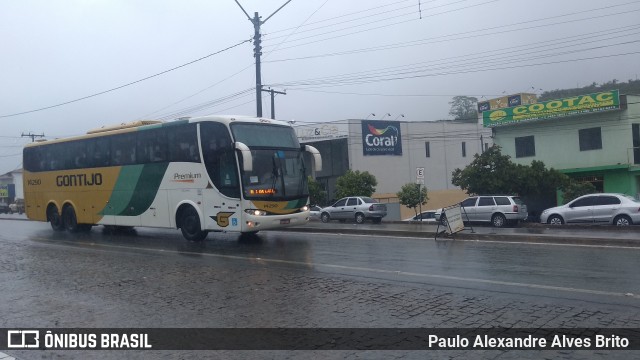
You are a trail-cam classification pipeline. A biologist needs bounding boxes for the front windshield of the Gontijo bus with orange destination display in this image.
[231,123,309,200]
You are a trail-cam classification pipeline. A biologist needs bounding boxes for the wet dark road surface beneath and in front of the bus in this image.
[0,220,640,359]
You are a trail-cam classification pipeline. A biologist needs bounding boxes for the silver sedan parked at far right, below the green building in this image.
[540,193,640,226]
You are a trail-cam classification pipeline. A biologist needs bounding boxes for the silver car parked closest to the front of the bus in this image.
[320,196,387,224]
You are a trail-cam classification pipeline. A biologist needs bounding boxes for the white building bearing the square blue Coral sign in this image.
[296,119,493,220]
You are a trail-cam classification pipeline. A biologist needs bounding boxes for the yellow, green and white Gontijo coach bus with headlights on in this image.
[23,116,322,241]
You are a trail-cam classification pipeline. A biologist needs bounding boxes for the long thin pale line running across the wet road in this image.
[35,238,640,299]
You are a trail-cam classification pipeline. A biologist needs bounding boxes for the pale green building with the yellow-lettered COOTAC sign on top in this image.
[482,90,640,204]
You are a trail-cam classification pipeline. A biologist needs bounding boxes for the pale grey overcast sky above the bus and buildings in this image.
[0,0,640,174]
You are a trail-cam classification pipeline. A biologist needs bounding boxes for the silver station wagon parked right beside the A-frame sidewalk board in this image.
[436,195,528,227]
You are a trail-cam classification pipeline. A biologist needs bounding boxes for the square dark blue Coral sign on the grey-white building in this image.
[362,120,402,156]
